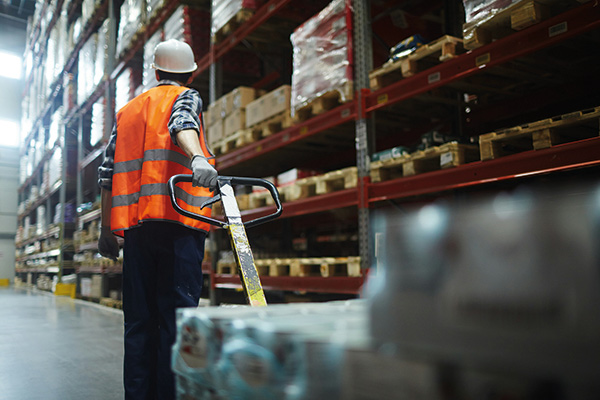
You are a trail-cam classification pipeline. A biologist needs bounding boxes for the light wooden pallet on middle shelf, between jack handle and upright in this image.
[280,167,358,201]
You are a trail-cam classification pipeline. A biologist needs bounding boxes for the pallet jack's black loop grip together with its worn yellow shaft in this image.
[168,175,283,306]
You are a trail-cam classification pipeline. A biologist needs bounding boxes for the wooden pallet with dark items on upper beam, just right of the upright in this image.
[369,35,463,90]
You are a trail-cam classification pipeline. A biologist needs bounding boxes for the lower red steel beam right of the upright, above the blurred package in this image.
[369,137,600,203]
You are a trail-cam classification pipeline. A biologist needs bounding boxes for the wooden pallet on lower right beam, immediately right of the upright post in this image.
[371,142,479,182]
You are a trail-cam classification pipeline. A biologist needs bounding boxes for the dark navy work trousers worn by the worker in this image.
[123,222,206,400]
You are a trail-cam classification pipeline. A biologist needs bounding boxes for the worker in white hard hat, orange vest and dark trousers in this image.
[98,40,217,399]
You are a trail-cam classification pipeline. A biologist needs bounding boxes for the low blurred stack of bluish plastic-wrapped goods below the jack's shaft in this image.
[173,300,369,400]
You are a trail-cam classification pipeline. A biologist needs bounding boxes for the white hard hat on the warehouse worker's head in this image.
[151,39,198,74]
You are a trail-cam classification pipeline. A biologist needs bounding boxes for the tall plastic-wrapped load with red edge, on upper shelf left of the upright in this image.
[291,0,353,113]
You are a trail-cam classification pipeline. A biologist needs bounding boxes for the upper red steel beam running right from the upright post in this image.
[366,1,600,112]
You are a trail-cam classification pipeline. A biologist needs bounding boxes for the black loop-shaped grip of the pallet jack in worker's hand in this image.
[168,175,283,228]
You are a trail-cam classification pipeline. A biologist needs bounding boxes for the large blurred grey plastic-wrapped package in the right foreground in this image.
[366,186,600,398]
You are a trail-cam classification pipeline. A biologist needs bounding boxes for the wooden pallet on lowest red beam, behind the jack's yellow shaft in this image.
[217,257,362,278]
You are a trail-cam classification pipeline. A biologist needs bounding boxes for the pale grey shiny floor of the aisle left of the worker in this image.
[0,287,123,400]
